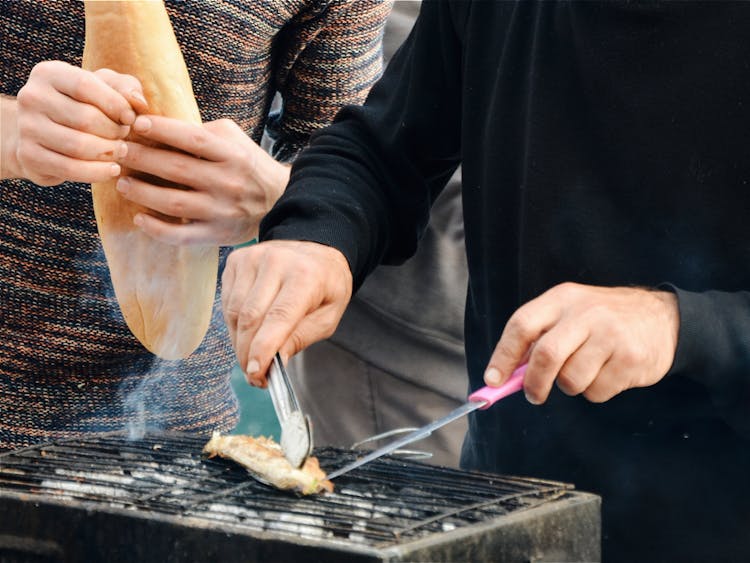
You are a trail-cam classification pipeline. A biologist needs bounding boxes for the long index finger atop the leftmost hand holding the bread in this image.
[29,61,136,125]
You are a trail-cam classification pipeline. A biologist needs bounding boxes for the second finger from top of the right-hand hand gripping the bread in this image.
[120,139,217,188]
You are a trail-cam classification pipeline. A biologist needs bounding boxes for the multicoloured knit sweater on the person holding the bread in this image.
[0,0,390,449]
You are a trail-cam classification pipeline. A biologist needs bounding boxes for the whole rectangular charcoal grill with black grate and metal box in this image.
[0,434,600,562]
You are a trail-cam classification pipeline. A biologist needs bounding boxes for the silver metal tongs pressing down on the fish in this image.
[268,353,313,467]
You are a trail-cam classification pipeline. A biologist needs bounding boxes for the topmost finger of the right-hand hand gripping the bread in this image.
[133,115,228,161]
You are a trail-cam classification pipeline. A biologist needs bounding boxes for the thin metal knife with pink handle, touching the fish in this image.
[328,364,526,479]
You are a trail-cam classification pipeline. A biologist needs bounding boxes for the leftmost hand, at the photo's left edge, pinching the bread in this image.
[2,61,147,186]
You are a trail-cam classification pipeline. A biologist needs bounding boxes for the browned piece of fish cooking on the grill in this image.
[203,432,333,495]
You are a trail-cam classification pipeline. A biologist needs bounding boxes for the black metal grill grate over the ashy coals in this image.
[0,434,572,548]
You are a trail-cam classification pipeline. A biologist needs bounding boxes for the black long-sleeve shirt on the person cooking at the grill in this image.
[261,0,750,561]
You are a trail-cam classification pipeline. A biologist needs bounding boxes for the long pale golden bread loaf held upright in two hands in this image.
[83,0,219,360]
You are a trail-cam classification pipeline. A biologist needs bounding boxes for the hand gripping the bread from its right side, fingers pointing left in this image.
[117,115,290,246]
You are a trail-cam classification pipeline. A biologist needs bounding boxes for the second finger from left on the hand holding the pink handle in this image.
[524,321,589,405]
